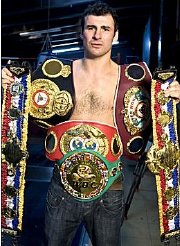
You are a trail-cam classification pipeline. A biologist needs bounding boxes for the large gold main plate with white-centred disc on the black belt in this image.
[30,79,73,119]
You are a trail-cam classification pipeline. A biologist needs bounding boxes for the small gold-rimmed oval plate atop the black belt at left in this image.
[42,59,71,78]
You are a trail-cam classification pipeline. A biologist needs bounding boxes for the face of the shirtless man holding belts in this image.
[82,15,114,58]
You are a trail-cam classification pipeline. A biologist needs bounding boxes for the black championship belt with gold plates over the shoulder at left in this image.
[29,58,75,128]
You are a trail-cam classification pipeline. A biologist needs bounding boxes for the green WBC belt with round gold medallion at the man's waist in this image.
[57,150,122,201]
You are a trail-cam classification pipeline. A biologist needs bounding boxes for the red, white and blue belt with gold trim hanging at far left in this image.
[1,66,31,236]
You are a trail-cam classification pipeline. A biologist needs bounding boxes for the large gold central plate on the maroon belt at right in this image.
[124,86,151,135]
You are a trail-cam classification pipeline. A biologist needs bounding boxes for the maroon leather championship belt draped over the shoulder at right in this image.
[115,62,151,160]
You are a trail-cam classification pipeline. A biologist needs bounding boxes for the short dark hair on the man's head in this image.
[81,1,118,32]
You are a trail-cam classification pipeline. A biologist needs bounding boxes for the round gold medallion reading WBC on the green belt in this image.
[60,152,108,199]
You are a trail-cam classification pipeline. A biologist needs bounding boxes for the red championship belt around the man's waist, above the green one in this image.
[45,120,123,162]
